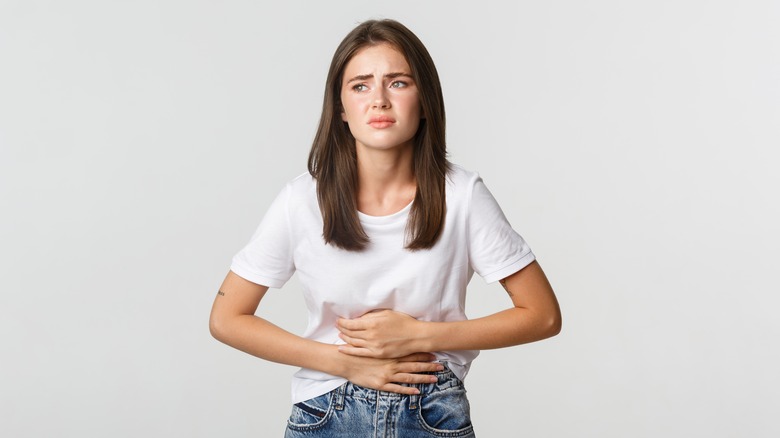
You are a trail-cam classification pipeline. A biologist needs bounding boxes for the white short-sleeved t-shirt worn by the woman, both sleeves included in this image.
[230,165,534,403]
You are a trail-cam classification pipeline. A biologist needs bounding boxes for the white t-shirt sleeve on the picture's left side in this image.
[230,185,295,288]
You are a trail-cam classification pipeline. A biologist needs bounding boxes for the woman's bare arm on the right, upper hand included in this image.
[338,261,561,357]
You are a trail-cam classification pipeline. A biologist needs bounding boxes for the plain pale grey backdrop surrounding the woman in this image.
[0,0,780,438]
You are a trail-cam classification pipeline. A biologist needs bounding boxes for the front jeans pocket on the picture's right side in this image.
[418,386,473,437]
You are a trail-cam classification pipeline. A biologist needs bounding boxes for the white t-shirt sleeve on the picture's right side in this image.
[468,177,535,283]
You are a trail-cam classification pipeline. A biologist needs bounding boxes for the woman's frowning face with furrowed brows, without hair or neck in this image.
[341,44,421,149]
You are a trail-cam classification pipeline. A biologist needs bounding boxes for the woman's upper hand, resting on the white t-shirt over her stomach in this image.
[336,310,424,359]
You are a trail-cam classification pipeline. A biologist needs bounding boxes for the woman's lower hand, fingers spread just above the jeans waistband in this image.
[340,353,444,395]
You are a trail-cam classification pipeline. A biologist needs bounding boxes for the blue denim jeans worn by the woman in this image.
[284,368,474,438]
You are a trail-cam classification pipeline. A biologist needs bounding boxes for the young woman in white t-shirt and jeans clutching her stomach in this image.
[210,20,561,438]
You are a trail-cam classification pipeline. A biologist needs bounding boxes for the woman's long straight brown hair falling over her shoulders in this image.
[309,20,450,251]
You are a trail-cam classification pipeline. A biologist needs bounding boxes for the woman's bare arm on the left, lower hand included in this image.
[209,271,440,394]
